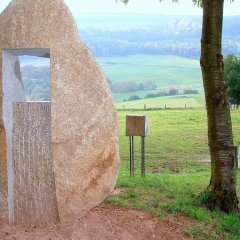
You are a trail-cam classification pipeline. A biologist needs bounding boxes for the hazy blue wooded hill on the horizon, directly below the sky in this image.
[74,13,240,58]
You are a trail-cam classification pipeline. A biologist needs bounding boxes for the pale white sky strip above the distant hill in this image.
[0,0,240,16]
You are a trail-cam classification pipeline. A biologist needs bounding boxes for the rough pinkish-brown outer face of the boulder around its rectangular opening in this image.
[0,0,119,221]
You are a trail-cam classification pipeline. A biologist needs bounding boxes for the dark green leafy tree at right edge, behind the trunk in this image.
[224,54,240,107]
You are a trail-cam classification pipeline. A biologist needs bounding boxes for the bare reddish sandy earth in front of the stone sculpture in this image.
[0,205,190,240]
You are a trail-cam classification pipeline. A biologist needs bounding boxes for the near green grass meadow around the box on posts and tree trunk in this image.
[106,109,240,239]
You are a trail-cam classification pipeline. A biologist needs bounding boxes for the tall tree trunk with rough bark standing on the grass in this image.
[201,0,238,213]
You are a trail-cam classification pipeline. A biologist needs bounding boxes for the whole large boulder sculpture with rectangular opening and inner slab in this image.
[0,0,119,223]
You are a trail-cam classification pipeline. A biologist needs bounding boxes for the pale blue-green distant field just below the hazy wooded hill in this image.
[97,55,203,102]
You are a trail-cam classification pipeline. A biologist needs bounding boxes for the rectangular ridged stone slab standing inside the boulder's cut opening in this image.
[13,102,59,224]
